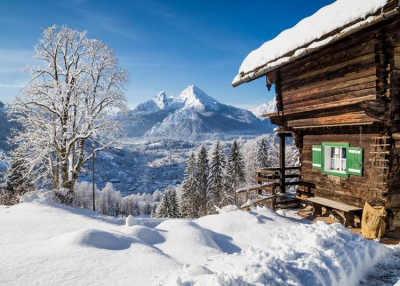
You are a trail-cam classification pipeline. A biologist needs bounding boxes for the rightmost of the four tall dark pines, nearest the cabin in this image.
[224,140,246,204]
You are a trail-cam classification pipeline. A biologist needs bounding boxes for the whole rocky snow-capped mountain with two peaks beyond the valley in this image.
[119,85,272,140]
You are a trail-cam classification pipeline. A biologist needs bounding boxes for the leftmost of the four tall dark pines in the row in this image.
[182,153,197,218]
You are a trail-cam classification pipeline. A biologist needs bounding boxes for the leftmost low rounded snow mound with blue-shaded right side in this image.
[54,229,134,250]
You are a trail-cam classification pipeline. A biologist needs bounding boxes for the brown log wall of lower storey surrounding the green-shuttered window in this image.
[300,130,388,207]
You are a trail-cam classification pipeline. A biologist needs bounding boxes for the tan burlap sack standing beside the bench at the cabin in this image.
[361,203,386,239]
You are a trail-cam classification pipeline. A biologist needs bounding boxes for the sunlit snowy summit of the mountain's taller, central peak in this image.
[174,85,219,110]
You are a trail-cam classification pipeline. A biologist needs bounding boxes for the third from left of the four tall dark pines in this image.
[209,141,226,209]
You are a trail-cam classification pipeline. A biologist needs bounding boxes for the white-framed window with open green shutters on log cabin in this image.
[312,143,363,178]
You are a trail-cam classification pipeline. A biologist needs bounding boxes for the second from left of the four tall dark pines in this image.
[196,145,210,216]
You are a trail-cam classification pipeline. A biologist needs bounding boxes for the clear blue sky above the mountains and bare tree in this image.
[0,0,334,108]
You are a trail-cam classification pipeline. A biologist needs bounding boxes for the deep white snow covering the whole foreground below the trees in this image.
[0,193,391,285]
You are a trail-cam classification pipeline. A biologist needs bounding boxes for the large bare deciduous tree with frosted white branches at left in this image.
[8,26,128,190]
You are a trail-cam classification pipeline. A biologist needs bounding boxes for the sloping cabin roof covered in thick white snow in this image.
[232,0,398,87]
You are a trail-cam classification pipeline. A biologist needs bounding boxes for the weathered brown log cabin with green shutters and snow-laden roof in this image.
[233,0,400,228]
